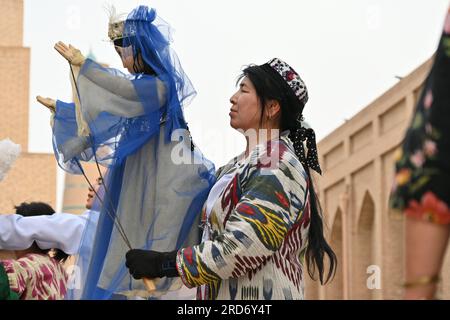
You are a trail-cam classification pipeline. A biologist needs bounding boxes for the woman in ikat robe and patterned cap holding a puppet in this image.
[126,58,336,300]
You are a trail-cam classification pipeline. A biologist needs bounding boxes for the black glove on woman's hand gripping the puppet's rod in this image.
[125,249,179,279]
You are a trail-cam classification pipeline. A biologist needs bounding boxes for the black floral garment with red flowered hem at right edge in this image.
[390,8,450,224]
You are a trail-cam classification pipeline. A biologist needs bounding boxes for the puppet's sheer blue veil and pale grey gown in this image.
[53,6,215,299]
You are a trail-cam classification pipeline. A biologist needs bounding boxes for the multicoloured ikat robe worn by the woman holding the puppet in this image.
[177,135,310,300]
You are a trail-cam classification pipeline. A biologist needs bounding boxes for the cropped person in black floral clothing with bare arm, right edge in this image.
[390,8,450,299]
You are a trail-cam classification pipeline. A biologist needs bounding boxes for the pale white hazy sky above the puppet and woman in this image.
[24,0,449,170]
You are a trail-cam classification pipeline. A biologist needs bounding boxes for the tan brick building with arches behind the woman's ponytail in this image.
[307,55,450,299]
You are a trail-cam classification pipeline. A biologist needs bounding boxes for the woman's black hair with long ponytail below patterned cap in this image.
[238,64,337,284]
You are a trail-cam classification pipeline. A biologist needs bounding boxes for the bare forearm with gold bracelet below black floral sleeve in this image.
[404,217,450,299]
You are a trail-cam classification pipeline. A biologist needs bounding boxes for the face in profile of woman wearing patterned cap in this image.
[230,77,261,131]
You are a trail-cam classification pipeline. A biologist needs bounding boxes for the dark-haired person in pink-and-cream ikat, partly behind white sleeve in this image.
[0,202,68,300]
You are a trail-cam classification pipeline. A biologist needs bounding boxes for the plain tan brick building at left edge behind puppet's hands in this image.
[0,0,56,218]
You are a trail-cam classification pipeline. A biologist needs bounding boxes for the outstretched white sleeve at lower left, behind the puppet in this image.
[0,213,88,254]
